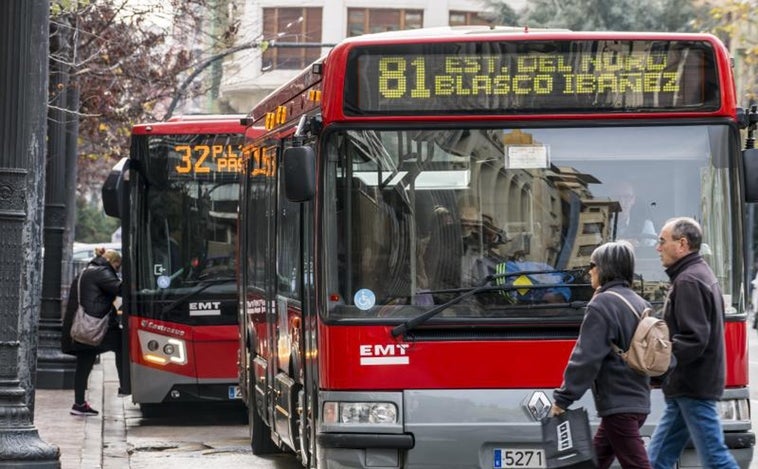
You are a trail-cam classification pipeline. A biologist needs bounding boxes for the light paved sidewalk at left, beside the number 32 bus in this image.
[34,352,129,469]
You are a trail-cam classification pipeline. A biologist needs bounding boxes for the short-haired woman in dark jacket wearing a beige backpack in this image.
[550,241,650,469]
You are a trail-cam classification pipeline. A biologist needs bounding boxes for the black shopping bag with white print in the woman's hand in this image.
[542,407,597,468]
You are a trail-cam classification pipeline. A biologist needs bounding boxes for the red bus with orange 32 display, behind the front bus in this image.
[103,115,255,410]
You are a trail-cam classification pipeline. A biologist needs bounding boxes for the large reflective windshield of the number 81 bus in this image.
[324,125,741,319]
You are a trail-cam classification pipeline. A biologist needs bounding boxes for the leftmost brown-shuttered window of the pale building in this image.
[263,8,321,72]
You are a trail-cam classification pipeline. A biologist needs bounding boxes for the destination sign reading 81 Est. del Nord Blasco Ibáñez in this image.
[344,40,719,115]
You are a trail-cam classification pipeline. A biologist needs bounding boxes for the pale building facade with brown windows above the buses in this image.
[221,0,526,112]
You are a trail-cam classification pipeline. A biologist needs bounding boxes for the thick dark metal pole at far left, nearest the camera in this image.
[0,0,60,468]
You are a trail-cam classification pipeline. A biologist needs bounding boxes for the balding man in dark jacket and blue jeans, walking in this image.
[648,217,738,469]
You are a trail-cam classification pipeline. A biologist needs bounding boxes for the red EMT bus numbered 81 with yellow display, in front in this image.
[239,28,758,469]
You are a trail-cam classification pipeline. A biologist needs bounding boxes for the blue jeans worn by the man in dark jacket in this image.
[648,397,739,469]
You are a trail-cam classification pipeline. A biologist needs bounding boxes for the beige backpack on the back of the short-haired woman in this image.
[608,290,671,376]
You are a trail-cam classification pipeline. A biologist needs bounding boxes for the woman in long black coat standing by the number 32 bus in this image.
[61,250,121,415]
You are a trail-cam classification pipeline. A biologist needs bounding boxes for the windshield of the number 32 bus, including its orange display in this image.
[133,134,242,297]
